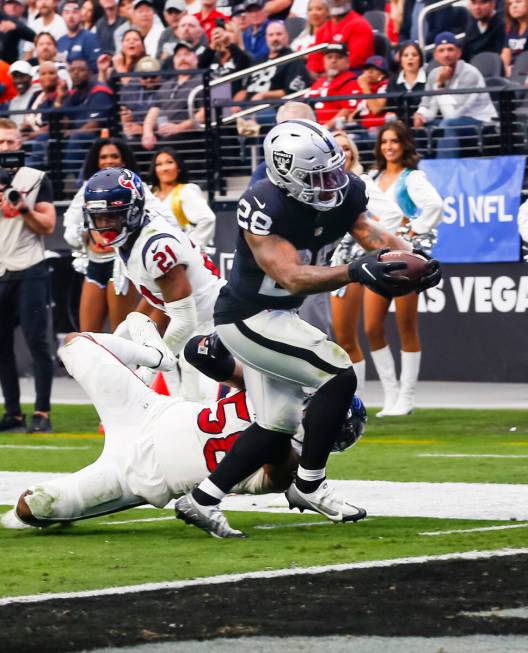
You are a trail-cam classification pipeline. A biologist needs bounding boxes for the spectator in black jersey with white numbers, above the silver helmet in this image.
[238,21,310,108]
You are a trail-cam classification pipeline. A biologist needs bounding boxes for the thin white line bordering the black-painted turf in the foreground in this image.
[0,548,528,607]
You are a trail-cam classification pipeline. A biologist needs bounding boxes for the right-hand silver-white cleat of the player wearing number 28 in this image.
[286,481,367,522]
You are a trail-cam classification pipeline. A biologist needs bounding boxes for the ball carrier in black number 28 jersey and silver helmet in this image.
[176,120,441,537]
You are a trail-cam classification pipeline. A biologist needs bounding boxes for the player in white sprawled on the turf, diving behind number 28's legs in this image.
[2,314,366,535]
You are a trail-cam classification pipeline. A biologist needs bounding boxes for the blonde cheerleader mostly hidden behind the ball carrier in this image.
[330,131,403,395]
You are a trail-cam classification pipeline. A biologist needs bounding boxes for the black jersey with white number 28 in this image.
[215,173,367,324]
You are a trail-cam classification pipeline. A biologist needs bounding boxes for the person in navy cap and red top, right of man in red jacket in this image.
[347,54,389,130]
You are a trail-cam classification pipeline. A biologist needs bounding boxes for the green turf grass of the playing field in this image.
[0,406,528,596]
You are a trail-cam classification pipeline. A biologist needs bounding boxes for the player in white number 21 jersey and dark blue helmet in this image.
[83,168,225,400]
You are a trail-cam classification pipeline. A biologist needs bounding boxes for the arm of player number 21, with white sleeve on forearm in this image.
[156,265,197,355]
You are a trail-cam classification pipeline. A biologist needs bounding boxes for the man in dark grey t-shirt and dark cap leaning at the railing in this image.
[141,41,204,150]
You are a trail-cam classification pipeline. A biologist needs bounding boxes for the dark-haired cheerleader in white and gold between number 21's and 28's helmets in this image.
[149,147,216,250]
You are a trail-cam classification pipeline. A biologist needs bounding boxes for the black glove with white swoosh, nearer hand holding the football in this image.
[348,249,416,298]
